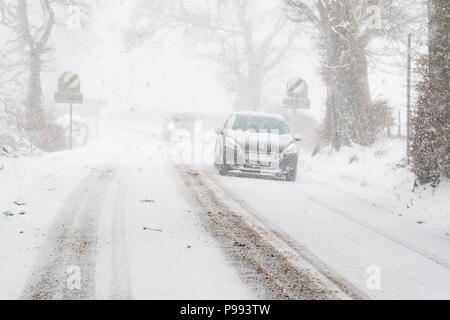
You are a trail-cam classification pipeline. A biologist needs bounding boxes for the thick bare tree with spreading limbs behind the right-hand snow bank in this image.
[285,0,424,150]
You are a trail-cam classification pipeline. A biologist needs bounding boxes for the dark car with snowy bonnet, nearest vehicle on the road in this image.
[215,112,300,181]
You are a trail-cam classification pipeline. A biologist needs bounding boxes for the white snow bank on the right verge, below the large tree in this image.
[299,139,450,237]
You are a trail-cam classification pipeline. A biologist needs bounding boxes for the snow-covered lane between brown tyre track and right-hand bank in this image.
[205,169,450,299]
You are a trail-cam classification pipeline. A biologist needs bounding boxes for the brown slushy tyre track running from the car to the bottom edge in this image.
[177,166,367,300]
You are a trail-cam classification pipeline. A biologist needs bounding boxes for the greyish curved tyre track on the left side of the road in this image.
[22,164,117,300]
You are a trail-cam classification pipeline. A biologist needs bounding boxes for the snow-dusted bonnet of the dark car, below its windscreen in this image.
[225,130,295,152]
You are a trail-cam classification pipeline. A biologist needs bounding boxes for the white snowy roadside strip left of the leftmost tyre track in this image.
[0,134,124,299]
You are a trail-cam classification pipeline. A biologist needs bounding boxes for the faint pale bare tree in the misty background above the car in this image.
[127,0,298,110]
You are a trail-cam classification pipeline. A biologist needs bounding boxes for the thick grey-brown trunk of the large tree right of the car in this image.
[320,1,375,150]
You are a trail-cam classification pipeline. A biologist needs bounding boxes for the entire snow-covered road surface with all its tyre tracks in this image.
[0,120,450,299]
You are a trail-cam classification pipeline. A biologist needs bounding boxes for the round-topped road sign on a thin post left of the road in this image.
[55,71,83,149]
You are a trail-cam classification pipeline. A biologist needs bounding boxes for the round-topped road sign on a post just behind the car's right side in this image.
[283,78,311,136]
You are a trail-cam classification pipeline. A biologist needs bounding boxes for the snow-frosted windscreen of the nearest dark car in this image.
[232,115,289,135]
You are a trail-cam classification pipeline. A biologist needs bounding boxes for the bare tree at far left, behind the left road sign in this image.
[0,0,90,136]
